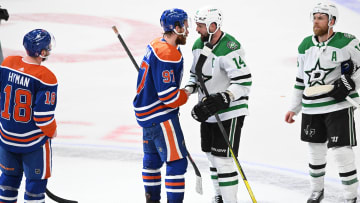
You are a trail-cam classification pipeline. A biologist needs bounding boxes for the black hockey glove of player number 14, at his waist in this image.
[191,92,230,122]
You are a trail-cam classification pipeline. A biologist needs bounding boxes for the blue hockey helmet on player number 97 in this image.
[160,8,188,32]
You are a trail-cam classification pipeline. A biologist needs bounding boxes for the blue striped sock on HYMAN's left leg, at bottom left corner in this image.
[0,173,22,203]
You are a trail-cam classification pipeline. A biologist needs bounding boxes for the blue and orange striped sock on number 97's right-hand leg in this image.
[165,158,188,203]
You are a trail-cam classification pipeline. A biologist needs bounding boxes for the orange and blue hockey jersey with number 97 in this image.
[133,38,188,127]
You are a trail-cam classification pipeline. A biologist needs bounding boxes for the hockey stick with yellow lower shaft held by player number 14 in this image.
[195,43,257,203]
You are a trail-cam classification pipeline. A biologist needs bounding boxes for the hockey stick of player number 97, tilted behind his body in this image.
[112,26,203,194]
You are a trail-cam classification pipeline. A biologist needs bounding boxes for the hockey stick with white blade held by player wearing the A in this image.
[304,70,360,109]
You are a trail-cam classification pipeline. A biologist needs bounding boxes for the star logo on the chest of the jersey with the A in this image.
[305,60,335,87]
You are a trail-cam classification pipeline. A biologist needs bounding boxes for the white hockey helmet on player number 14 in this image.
[195,6,223,34]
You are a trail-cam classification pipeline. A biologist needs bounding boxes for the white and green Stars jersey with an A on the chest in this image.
[290,32,360,114]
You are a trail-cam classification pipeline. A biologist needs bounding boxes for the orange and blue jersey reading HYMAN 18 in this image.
[0,56,58,153]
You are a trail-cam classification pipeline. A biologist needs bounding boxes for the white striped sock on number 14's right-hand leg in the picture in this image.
[214,156,239,203]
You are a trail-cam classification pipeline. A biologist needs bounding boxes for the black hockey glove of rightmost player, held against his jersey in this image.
[328,74,355,102]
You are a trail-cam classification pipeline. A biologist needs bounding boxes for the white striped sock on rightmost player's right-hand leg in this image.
[333,147,359,199]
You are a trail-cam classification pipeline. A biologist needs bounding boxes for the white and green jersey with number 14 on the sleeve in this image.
[186,33,252,123]
